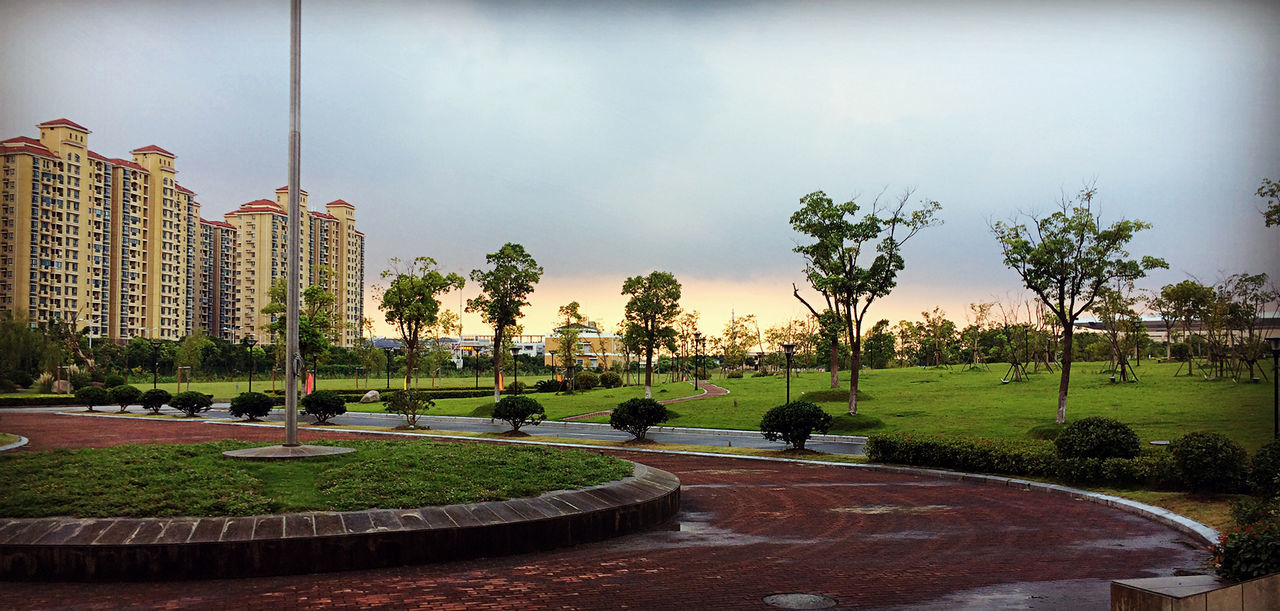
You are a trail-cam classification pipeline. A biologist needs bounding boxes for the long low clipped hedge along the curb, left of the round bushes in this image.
[867,433,1057,475]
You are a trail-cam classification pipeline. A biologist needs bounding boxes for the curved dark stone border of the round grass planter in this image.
[0,462,680,580]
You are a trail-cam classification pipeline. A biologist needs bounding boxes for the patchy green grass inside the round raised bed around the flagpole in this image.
[0,441,631,517]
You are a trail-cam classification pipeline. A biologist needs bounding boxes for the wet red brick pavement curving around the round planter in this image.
[0,414,1204,610]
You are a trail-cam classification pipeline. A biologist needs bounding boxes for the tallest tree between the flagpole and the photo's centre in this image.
[467,242,543,403]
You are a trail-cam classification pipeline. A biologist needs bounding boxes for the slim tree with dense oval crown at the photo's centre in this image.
[622,272,680,397]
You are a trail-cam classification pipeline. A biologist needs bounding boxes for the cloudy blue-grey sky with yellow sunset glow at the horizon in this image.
[0,0,1280,334]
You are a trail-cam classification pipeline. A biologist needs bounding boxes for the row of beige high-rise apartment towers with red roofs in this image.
[0,119,365,346]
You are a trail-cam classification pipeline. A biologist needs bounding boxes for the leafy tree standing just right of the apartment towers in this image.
[378,256,466,388]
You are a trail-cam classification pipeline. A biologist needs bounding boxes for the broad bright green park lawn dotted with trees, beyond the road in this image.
[368,361,1272,451]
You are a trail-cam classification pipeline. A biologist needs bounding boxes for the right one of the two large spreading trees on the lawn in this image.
[991,187,1169,424]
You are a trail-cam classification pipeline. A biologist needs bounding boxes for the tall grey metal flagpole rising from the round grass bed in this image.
[284,0,302,446]
